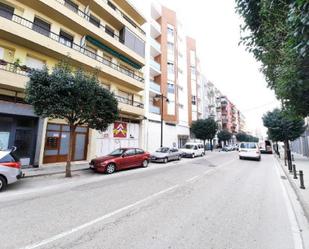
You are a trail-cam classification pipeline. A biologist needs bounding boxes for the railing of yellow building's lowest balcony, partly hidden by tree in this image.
[0,60,144,108]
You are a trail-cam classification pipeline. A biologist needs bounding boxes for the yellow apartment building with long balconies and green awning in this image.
[0,0,146,165]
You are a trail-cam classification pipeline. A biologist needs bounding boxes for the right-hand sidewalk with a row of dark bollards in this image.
[276,151,309,221]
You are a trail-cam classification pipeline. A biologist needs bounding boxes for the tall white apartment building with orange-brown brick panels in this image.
[145,2,191,151]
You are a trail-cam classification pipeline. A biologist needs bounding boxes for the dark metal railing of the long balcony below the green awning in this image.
[2,14,144,82]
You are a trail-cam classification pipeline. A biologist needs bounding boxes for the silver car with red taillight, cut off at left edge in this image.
[0,148,23,191]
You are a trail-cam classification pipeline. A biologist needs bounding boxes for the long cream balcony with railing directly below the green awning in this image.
[0,14,144,90]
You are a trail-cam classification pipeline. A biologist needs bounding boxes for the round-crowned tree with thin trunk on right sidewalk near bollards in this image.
[263,109,306,169]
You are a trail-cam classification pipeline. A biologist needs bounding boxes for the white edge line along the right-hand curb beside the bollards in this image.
[273,158,304,249]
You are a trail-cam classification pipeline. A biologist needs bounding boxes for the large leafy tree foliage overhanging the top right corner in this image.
[235,0,309,117]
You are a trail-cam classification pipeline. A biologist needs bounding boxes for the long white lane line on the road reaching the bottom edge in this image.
[23,184,180,249]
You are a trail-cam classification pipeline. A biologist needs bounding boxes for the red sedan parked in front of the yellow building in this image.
[90,148,150,174]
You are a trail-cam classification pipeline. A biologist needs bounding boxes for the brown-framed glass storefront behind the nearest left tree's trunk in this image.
[43,123,89,163]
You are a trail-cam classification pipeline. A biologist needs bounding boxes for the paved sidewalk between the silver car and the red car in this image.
[22,161,89,177]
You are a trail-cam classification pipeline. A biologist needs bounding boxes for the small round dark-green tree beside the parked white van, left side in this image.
[191,118,218,152]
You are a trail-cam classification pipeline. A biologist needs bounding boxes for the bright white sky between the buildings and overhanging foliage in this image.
[131,0,279,135]
